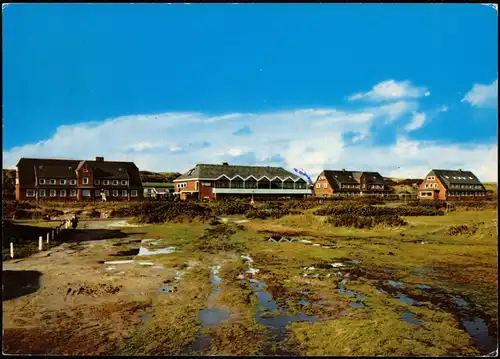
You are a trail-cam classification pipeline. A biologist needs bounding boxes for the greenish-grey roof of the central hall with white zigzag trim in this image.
[175,164,303,181]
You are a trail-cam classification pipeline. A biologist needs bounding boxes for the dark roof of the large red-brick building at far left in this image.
[17,158,142,187]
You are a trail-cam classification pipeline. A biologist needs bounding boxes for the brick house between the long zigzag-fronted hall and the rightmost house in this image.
[314,169,391,197]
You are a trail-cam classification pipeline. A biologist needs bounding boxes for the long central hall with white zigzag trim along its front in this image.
[174,162,312,200]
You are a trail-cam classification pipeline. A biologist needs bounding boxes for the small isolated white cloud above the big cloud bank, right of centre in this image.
[348,80,431,101]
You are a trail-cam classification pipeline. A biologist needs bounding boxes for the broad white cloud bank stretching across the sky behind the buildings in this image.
[3,102,497,181]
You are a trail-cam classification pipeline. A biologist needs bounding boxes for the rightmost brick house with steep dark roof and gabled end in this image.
[418,169,486,201]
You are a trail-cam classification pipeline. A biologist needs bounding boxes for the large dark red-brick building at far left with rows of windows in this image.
[16,157,143,201]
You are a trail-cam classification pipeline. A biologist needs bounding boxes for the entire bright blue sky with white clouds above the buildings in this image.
[2,4,498,182]
